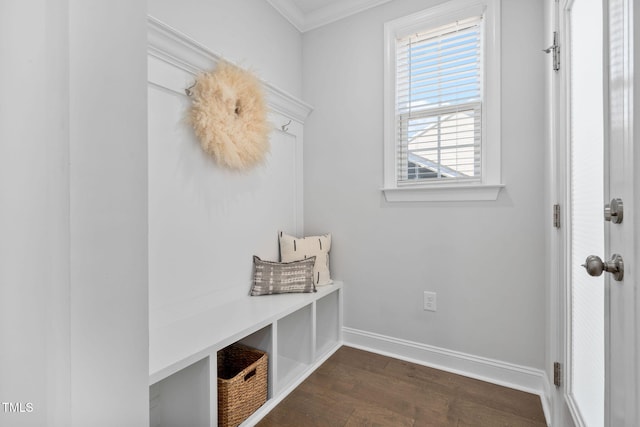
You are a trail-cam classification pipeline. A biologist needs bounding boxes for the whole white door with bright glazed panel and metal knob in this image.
[554,0,640,427]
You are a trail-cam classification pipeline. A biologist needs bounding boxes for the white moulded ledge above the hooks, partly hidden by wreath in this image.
[147,15,313,123]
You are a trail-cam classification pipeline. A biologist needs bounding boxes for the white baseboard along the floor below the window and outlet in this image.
[342,327,551,425]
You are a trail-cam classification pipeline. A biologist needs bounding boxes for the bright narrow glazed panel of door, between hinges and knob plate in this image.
[562,0,607,427]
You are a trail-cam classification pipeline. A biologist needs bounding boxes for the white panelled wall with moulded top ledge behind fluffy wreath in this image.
[148,18,311,329]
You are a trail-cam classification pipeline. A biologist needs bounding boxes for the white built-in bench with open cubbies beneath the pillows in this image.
[149,282,342,427]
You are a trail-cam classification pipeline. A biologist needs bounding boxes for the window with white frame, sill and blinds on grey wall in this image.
[384,0,502,201]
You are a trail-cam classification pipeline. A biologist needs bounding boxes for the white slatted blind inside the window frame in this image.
[396,16,483,184]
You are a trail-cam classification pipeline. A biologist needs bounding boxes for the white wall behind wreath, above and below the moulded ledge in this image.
[149,0,302,328]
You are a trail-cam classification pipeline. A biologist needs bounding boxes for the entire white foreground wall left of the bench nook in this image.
[0,0,148,426]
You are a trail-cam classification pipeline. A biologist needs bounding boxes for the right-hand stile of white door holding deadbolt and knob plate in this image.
[604,0,640,427]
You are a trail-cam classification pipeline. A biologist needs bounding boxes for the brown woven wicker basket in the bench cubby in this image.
[218,344,268,427]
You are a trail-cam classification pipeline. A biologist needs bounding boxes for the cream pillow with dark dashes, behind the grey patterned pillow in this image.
[280,232,332,286]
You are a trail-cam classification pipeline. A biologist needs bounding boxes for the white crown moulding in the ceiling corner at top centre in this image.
[267,0,391,32]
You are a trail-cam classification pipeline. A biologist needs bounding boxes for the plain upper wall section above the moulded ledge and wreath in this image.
[148,0,302,97]
